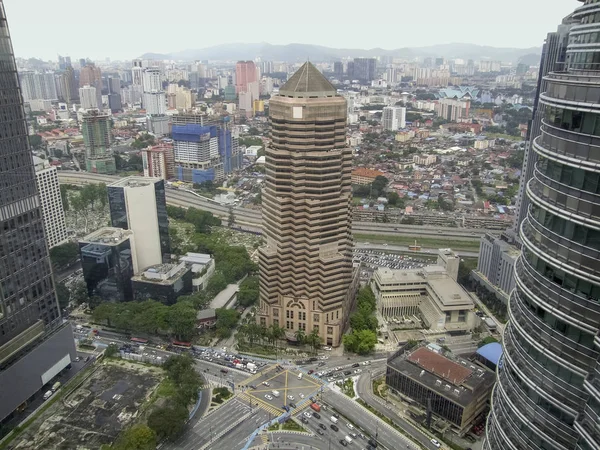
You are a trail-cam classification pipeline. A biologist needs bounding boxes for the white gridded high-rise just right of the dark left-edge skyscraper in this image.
[33,156,68,248]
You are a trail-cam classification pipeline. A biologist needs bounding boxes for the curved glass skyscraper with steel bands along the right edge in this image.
[483,0,600,450]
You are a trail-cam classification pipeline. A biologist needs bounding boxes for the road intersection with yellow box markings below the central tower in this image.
[244,366,322,416]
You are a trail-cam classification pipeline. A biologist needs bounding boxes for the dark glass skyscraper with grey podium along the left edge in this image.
[0,2,77,423]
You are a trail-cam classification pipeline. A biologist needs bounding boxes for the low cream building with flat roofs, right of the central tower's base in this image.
[371,265,475,334]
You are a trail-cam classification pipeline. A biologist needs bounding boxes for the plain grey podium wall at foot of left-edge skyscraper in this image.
[0,324,77,420]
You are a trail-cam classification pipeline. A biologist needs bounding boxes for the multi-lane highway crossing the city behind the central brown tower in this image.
[58,171,486,241]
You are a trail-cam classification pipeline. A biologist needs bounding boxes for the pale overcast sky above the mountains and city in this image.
[3,0,581,60]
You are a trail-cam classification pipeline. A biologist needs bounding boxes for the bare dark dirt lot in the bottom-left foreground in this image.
[8,360,163,450]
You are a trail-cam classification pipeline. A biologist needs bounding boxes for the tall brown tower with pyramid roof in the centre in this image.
[259,62,354,346]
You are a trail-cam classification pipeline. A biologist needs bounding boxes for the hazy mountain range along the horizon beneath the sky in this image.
[141,42,541,64]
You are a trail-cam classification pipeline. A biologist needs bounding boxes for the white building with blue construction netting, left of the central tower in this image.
[171,114,243,183]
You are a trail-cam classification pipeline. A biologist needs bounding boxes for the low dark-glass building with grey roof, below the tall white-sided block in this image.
[131,262,192,305]
